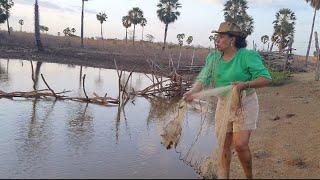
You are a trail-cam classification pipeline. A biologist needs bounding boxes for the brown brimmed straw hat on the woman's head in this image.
[212,22,247,38]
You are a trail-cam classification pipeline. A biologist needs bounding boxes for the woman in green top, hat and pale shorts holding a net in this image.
[183,22,271,178]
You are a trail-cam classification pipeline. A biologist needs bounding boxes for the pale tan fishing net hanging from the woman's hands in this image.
[161,86,241,178]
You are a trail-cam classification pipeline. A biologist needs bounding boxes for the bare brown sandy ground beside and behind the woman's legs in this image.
[231,73,320,178]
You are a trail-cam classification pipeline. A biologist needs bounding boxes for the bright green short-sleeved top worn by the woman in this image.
[197,48,272,87]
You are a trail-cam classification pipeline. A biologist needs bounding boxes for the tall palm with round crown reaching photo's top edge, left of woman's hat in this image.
[157,0,182,49]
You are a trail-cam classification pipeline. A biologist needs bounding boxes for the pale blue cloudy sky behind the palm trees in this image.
[0,0,320,55]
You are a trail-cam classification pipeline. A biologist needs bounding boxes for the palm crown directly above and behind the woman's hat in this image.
[223,0,253,35]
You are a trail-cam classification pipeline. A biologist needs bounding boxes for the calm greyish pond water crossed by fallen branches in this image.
[0,59,215,178]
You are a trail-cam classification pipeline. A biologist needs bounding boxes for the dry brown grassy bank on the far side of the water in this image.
[0,31,209,75]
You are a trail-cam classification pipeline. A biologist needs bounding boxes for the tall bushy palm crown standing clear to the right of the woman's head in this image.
[273,8,296,52]
